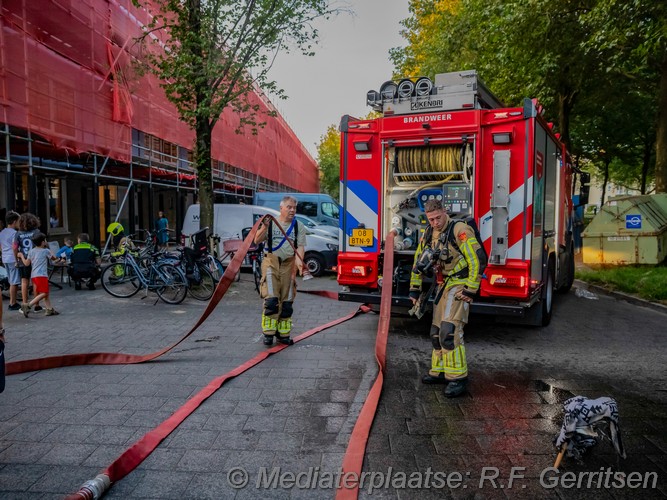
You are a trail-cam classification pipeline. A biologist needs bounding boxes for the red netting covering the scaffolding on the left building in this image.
[0,0,319,192]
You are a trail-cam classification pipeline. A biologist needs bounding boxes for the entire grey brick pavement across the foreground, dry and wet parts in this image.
[0,274,667,499]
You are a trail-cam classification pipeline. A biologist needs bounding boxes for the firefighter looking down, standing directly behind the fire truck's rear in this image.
[410,200,485,398]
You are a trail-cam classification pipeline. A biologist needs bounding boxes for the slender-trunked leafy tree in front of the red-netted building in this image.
[133,0,337,227]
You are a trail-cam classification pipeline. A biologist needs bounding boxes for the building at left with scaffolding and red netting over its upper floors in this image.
[0,0,319,243]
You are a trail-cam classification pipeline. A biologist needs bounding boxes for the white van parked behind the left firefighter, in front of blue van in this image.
[182,203,338,276]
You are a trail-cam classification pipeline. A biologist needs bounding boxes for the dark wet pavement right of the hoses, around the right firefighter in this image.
[362,291,667,499]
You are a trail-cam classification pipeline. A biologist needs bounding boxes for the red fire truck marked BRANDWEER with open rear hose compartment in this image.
[338,71,574,325]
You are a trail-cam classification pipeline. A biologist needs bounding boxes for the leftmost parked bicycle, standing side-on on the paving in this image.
[100,247,188,304]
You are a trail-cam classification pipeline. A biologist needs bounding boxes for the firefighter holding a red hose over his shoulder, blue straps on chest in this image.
[254,196,306,346]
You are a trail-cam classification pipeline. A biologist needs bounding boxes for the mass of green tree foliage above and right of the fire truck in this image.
[392,0,667,197]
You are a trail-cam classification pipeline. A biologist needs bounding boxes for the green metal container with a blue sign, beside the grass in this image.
[581,193,667,265]
